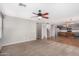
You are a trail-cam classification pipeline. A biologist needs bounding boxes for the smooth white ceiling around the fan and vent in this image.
[1,3,79,23]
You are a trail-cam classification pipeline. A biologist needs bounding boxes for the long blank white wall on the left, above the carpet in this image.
[2,16,36,46]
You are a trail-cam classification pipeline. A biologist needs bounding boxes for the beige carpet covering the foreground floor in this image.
[0,40,79,56]
